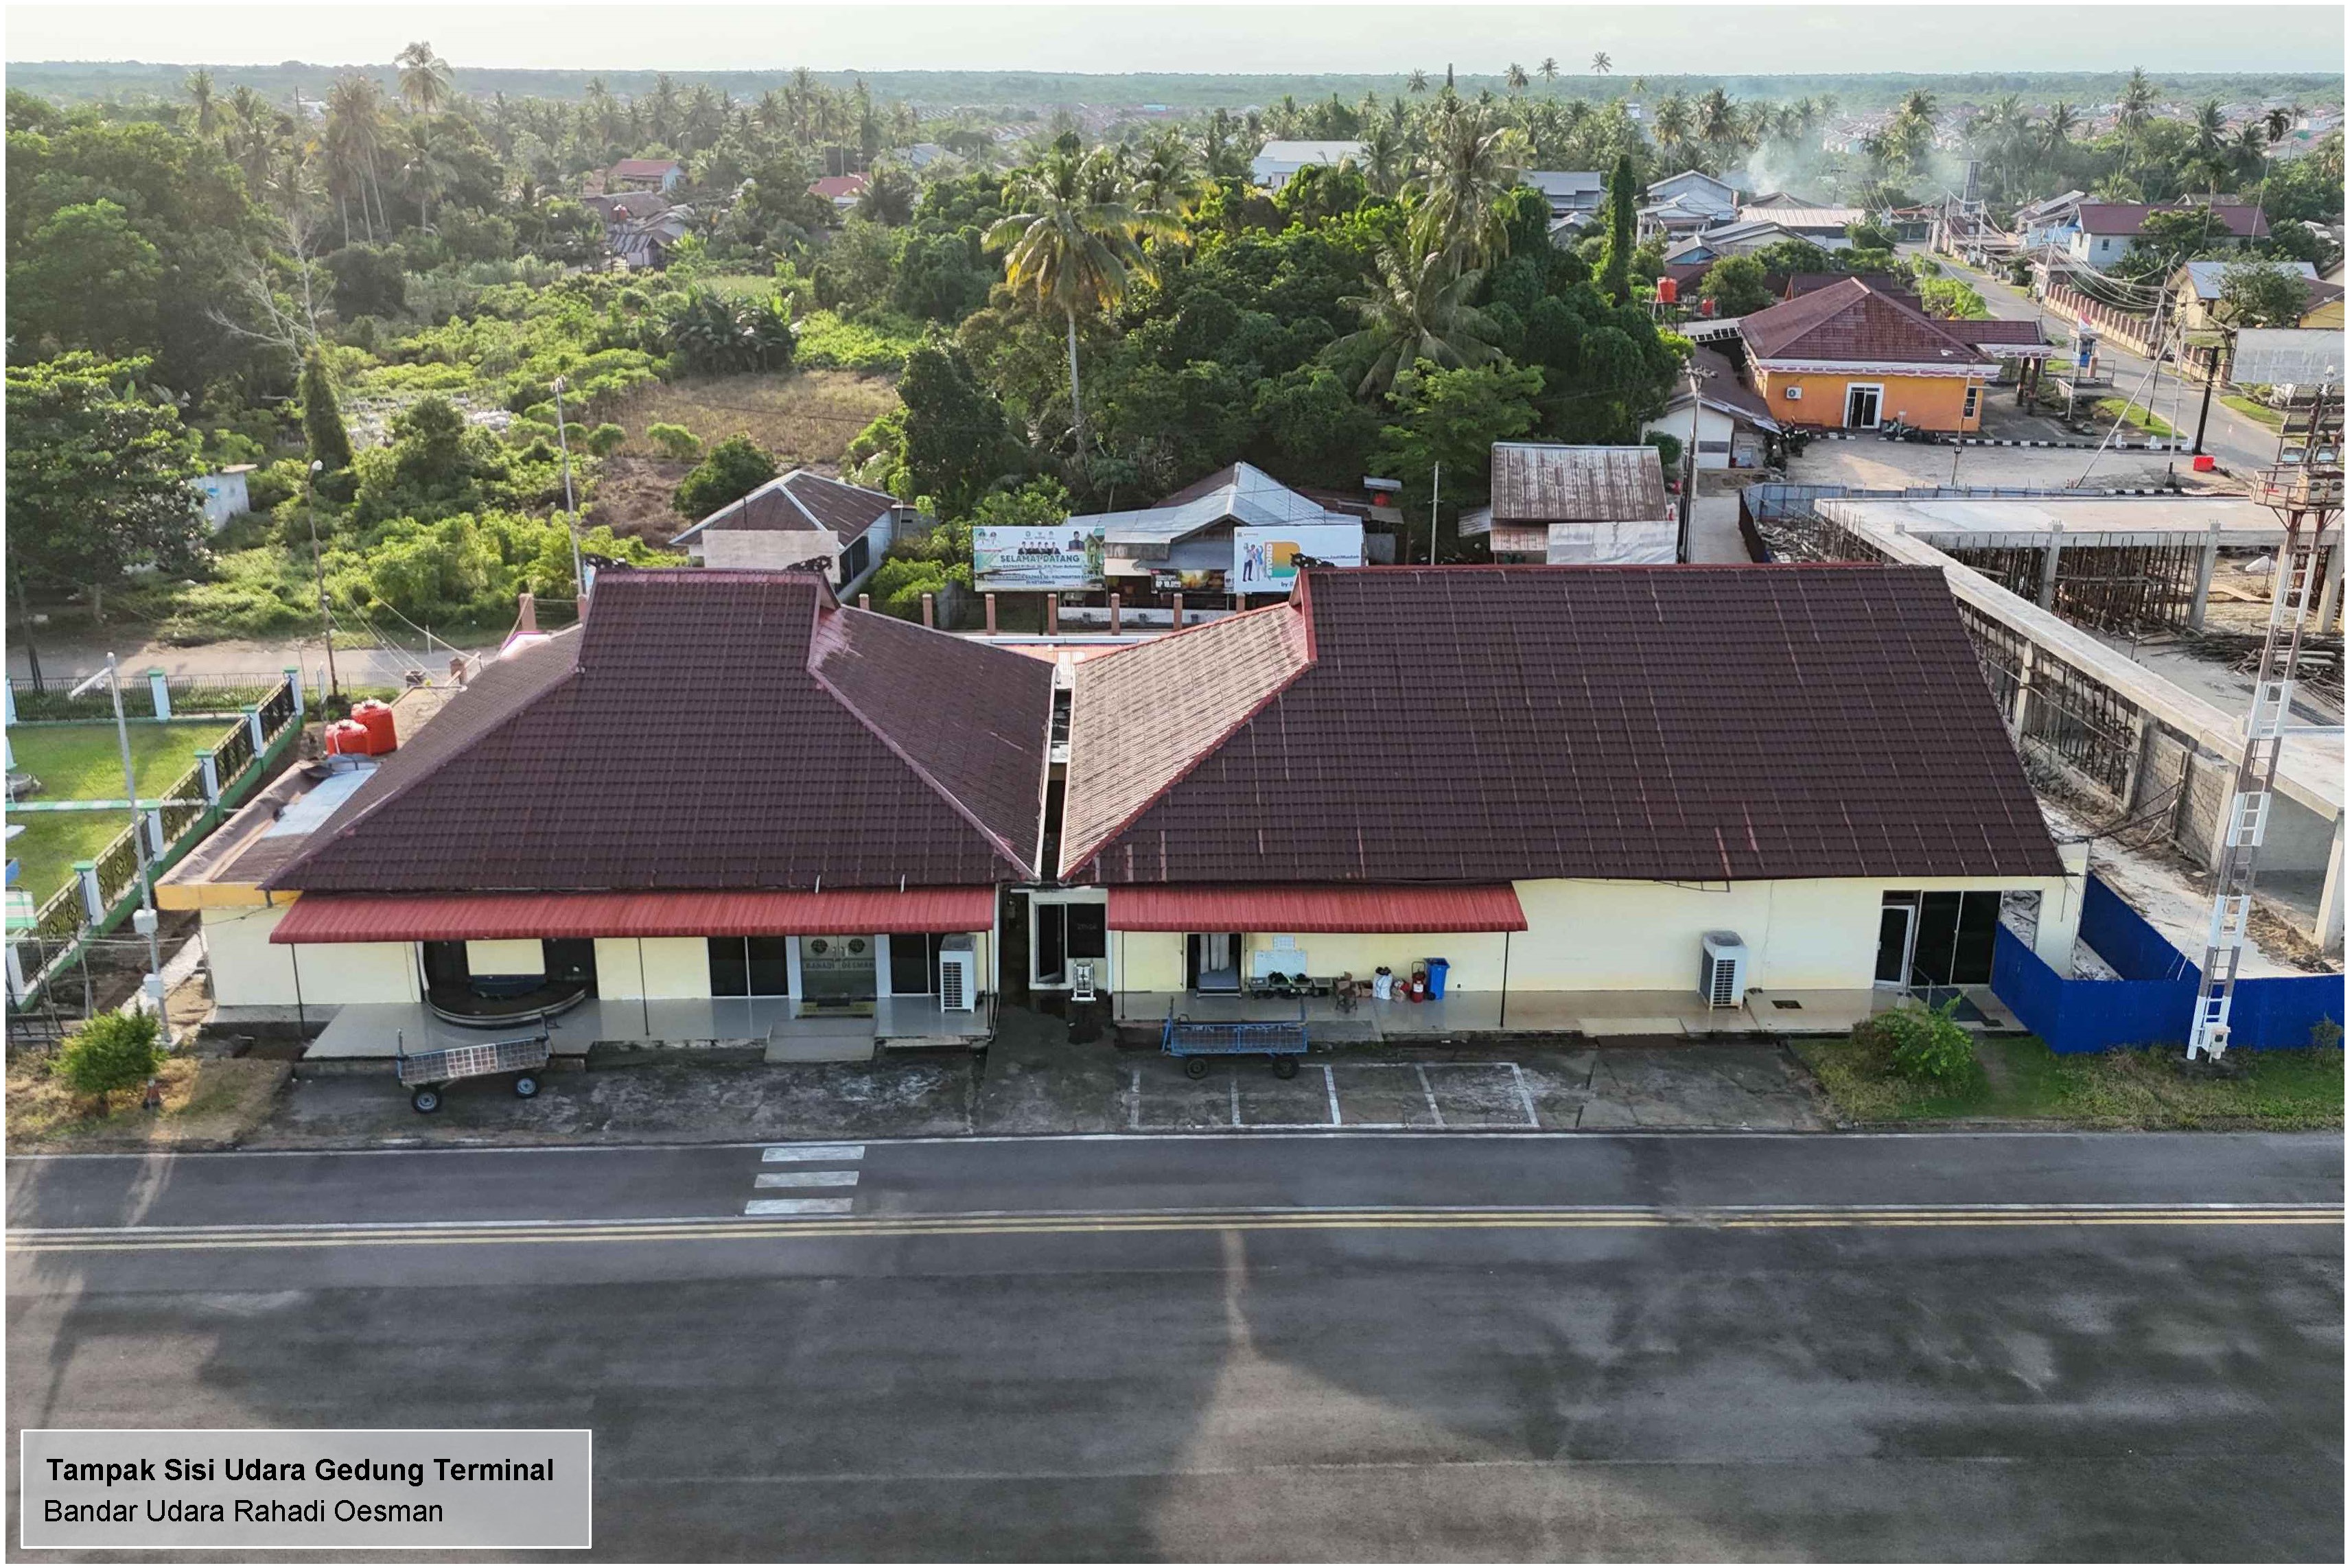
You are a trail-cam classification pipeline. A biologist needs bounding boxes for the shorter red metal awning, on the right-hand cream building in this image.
[1110,882,1526,931]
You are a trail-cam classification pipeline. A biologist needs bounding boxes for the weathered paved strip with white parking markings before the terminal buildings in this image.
[247,1011,1832,1147]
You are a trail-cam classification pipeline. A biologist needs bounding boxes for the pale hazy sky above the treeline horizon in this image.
[7,0,2345,75]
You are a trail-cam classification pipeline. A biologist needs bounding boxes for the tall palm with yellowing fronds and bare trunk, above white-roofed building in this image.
[983,145,1180,454]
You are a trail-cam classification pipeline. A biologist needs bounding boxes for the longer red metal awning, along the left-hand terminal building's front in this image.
[270,889,997,943]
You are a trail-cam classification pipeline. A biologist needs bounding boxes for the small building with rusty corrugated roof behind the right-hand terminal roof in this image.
[1460,442,1679,567]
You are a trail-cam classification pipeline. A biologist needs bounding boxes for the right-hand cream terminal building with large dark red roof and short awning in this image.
[1051,564,2075,1011]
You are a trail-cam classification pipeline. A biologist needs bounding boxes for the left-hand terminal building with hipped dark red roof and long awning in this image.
[176,569,1053,1055]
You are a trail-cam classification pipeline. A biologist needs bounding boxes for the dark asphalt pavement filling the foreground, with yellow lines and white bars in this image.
[7,1136,2345,1561]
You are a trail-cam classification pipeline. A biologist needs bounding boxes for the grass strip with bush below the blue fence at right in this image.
[1797,1037,2345,1131]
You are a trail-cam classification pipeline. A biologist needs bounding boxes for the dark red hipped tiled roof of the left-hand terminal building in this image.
[266,571,1053,893]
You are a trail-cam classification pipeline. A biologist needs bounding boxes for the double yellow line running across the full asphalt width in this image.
[7,1204,2345,1253]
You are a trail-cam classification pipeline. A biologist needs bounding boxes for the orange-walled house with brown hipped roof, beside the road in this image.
[1740,277,1997,432]
